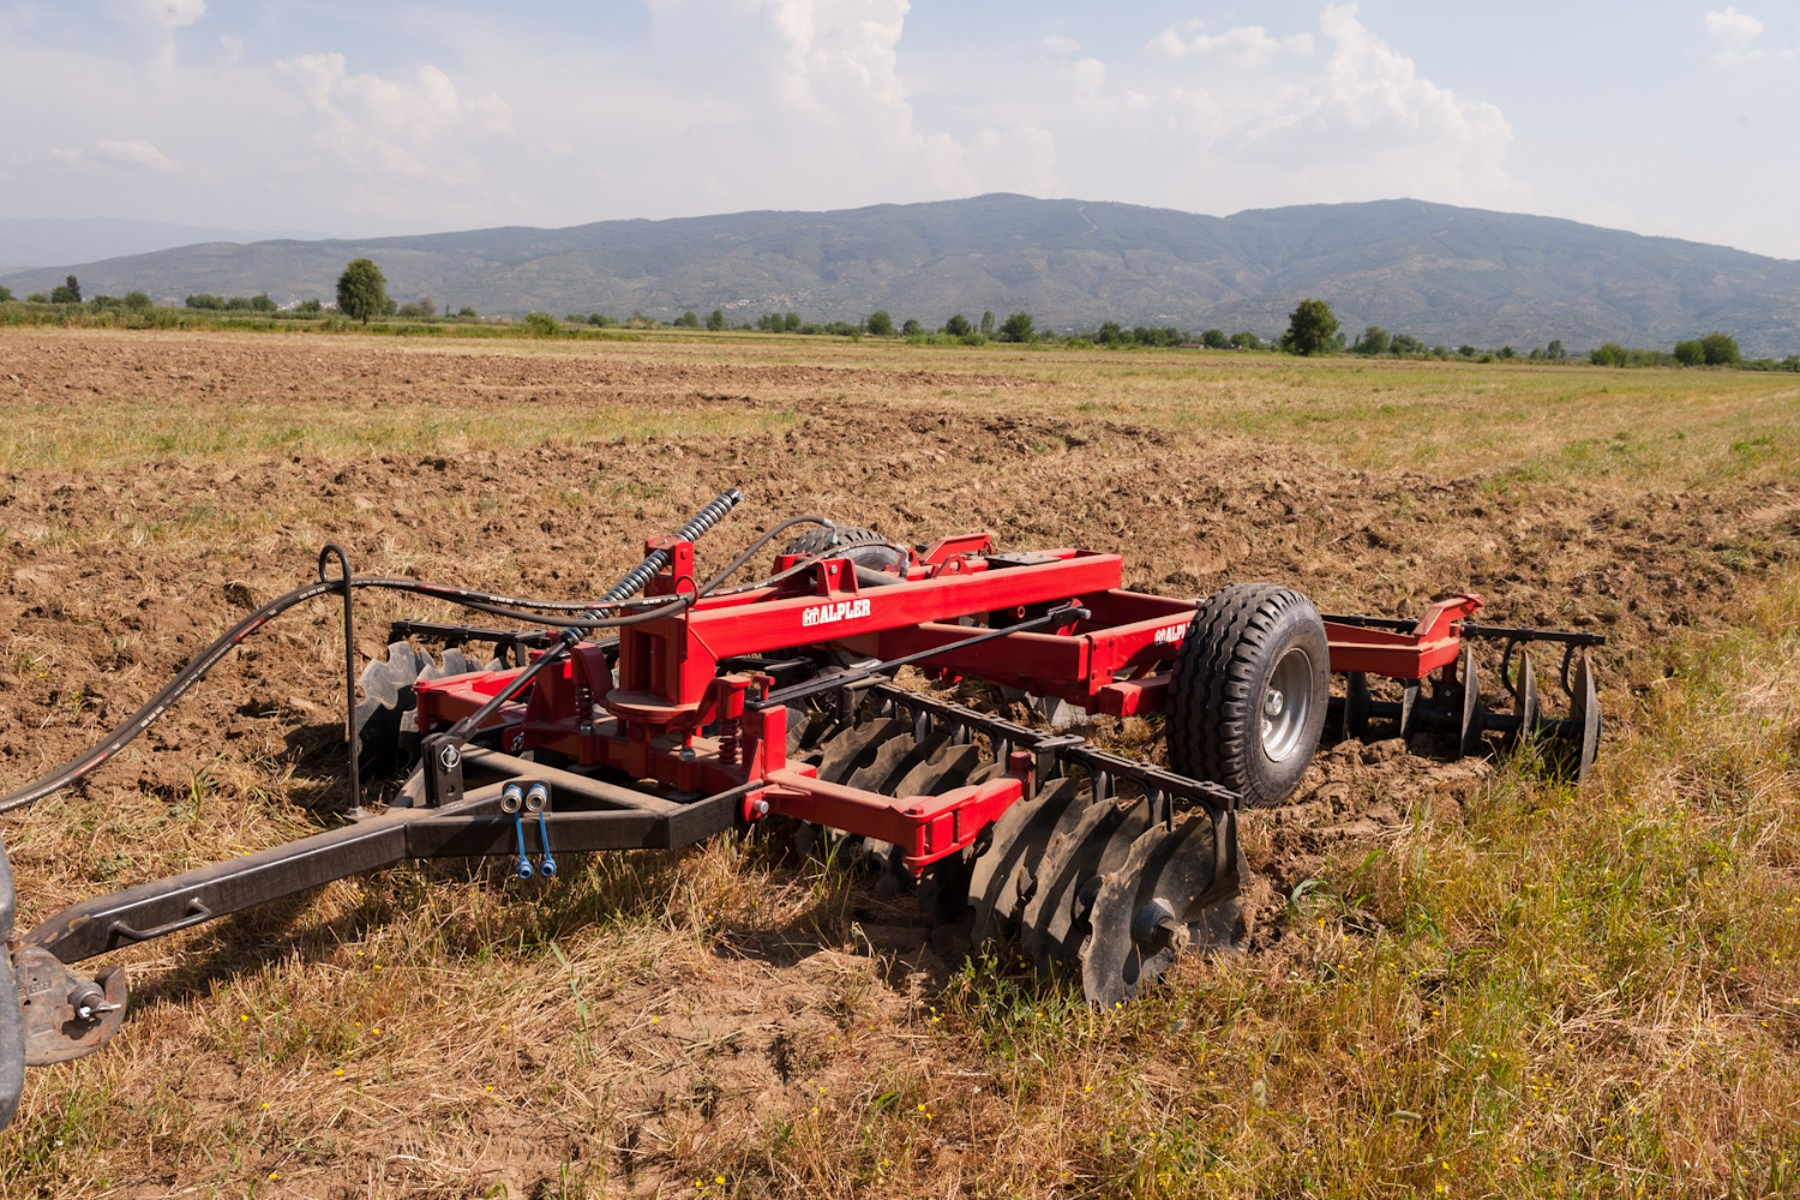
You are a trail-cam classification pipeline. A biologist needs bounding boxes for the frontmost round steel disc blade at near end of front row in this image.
[1082,817,1238,1007]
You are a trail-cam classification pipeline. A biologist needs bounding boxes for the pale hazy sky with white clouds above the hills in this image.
[0,0,1800,259]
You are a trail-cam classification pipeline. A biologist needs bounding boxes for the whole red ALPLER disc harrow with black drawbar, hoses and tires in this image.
[0,489,1604,1123]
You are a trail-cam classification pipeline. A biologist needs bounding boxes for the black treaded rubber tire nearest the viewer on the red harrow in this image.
[1168,583,1330,808]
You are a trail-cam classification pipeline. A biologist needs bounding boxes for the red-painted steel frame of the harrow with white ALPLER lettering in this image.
[416,534,1481,873]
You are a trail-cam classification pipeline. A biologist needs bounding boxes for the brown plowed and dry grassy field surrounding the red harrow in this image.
[0,331,1800,1196]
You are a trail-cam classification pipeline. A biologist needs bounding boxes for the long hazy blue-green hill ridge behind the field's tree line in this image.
[0,194,1800,356]
